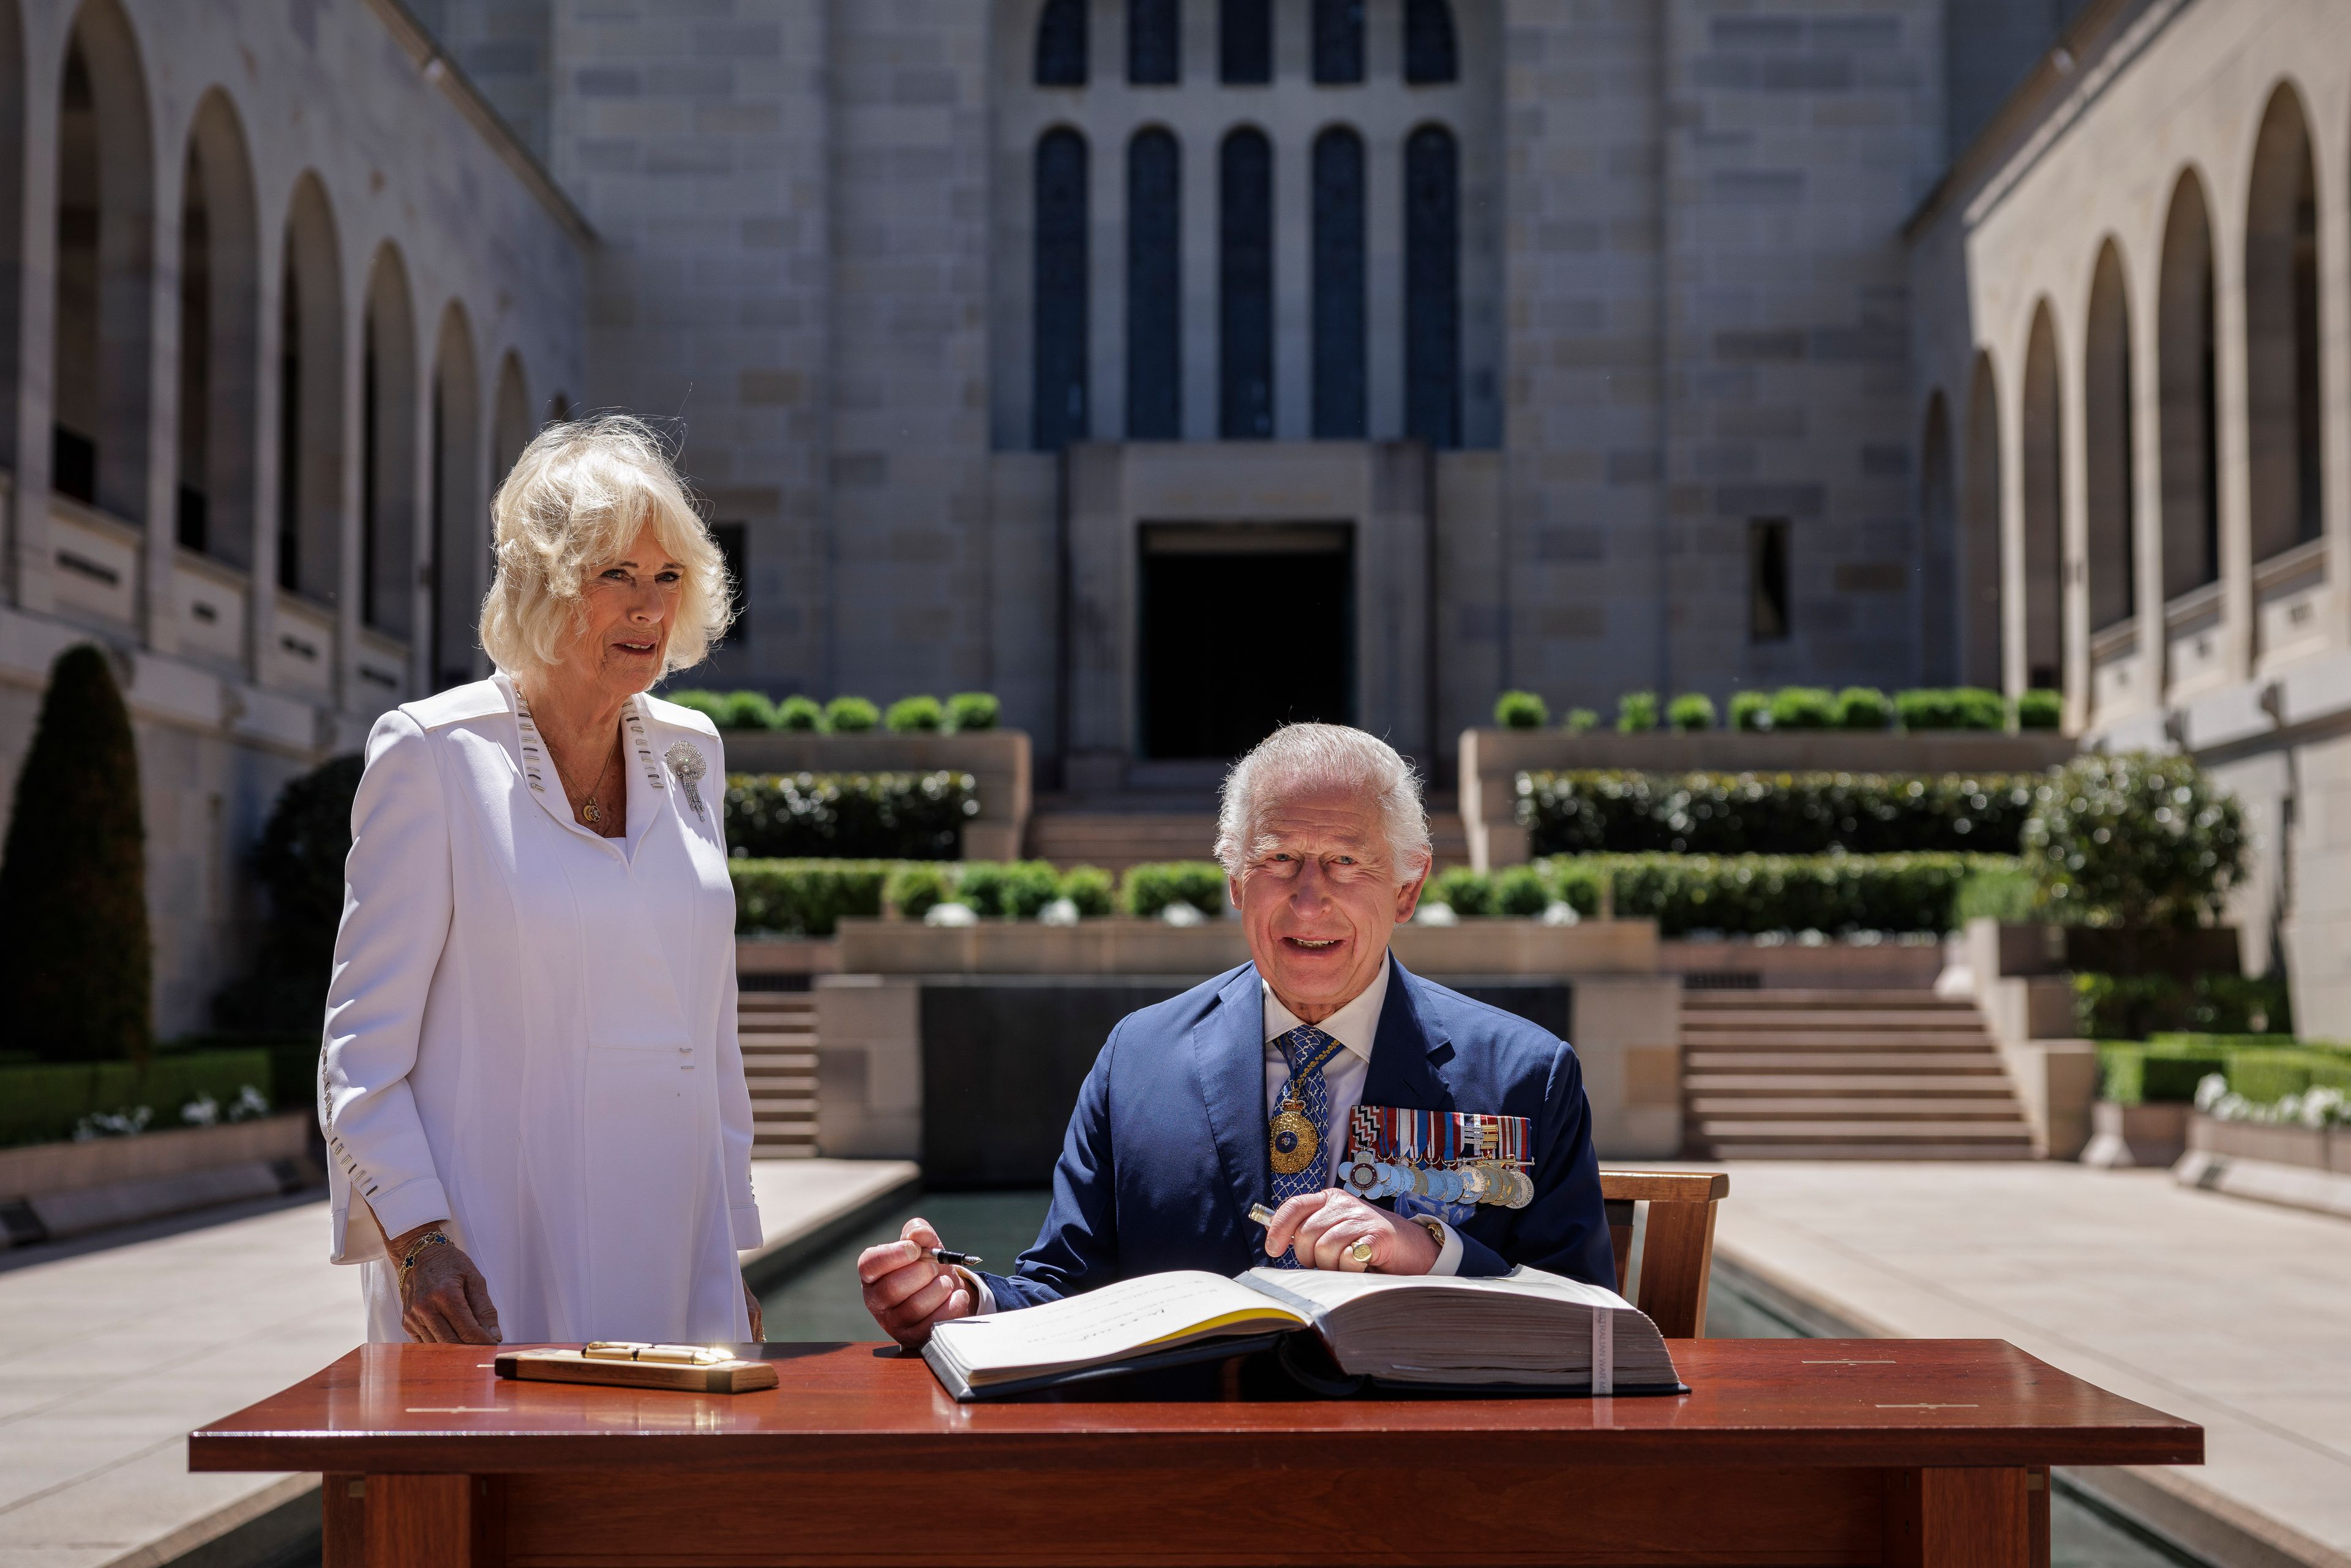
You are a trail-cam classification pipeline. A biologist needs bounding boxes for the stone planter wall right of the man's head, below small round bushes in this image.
[1460,729,2080,872]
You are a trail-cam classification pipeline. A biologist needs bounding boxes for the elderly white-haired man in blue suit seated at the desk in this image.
[858,724,1615,1347]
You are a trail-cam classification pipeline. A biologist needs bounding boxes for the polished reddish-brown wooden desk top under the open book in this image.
[188,1340,2203,1472]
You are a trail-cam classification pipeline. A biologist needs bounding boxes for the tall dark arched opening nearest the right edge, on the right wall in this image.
[2245,82,2325,562]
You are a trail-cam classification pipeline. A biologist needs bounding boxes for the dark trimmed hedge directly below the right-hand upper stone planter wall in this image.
[1517,769,2045,856]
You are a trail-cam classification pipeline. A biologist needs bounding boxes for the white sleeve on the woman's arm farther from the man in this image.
[320,708,451,1262]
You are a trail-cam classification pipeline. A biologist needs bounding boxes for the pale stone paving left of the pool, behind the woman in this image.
[0,1159,917,1568]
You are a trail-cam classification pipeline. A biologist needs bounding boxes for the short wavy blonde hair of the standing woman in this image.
[482,414,733,675]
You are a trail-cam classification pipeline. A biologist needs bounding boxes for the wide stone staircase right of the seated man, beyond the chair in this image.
[1681,989,2034,1159]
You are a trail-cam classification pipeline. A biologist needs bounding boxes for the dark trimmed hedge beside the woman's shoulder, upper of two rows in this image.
[727,771,980,860]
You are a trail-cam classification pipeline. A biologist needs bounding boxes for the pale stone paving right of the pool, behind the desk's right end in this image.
[1716,1161,2351,1568]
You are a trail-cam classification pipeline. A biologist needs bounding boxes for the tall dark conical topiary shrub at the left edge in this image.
[0,642,155,1062]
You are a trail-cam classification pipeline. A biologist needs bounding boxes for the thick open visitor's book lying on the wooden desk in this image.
[921,1267,1688,1401]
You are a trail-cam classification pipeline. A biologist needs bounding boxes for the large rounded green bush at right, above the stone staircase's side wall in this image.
[2024,752,2245,926]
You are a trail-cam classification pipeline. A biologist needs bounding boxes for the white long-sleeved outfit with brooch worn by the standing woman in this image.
[320,675,759,1342]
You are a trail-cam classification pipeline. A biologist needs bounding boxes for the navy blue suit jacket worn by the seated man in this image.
[985,957,1615,1307]
